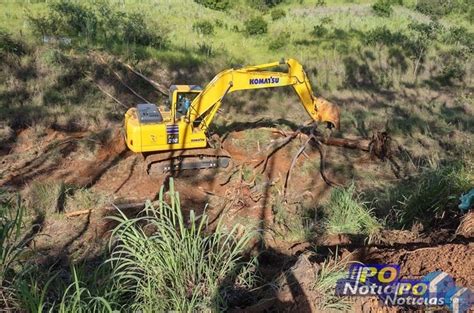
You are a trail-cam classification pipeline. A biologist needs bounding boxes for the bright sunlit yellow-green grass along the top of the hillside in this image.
[0,0,472,63]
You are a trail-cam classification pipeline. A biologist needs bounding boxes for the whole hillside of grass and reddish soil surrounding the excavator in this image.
[0,0,474,312]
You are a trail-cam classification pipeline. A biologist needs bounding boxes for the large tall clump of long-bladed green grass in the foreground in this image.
[111,181,254,312]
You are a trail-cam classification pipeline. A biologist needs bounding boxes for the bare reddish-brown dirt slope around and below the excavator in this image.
[0,128,474,312]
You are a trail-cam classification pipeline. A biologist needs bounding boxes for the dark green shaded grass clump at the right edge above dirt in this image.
[382,163,474,228]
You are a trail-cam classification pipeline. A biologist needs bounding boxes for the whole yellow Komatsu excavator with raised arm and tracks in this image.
[125,59,339,174]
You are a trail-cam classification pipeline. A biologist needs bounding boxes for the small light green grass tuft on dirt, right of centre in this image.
[324,184,382,235]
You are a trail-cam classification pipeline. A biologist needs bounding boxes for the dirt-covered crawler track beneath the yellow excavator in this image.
[143,148,231,175]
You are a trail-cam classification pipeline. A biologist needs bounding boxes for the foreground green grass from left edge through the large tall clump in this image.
[0,180,257,312]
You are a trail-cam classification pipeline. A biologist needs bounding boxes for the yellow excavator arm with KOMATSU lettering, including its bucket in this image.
[186,59,339,130]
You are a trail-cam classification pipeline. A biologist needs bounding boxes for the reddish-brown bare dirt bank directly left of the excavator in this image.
[0,129,128,188]
